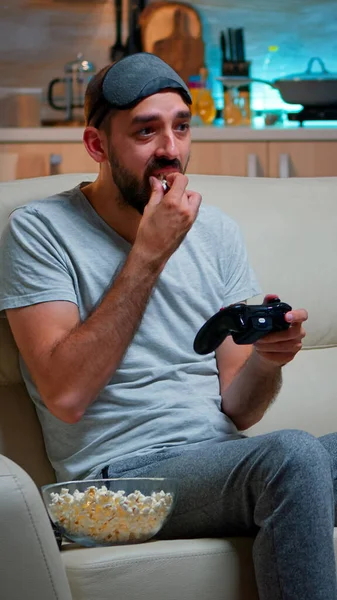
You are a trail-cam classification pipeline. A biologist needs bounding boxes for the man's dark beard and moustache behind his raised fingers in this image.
[109,149,189,215]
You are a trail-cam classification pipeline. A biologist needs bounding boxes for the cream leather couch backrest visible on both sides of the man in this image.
[0,174,337,484]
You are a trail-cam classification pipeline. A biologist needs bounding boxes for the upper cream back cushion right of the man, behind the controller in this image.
[190,175,337,347]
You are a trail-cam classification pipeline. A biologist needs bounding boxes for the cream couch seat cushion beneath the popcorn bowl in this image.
[61,538,258,600]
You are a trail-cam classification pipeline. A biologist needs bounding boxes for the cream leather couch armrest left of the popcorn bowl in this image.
[0,455,71,600]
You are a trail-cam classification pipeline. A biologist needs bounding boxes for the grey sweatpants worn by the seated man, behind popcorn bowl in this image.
[100,430,337,600]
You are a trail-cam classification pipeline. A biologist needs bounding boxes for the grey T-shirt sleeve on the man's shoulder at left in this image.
[0,207,77,311]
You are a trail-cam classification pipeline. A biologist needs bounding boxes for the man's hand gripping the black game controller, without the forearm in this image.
[254,295,308,367]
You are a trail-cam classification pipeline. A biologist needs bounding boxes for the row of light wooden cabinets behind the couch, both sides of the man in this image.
[0,140,337,181]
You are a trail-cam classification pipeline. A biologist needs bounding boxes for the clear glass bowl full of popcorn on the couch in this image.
[41,478,177,546]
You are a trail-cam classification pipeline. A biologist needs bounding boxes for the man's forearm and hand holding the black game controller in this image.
[216,300,308,431]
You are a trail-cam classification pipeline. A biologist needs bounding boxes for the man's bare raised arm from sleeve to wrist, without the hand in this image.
[6,255,163,423]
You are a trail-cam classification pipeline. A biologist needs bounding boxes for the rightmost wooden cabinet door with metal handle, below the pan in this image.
[268,141,337,177]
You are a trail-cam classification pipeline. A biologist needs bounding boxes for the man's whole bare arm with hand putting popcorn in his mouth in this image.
[7,174,201,423]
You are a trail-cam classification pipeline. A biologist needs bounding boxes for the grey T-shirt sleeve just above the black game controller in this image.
[223,219,261,306]
